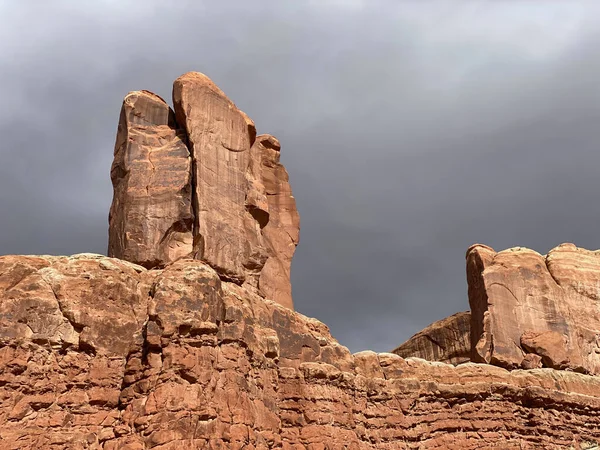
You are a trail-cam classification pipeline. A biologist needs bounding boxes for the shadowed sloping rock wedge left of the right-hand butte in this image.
[392,311,471,364]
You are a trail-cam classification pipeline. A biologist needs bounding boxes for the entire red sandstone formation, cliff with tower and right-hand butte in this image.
[0,73,600,450]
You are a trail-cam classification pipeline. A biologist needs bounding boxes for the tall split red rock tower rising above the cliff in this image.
[109,72,300,308]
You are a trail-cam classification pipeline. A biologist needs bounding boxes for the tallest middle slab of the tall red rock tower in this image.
[173,72,253,282]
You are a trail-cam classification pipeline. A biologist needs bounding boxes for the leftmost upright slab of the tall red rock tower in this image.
[108,91,193,268]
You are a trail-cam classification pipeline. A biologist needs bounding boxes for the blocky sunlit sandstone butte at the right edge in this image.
[467,244,600,375]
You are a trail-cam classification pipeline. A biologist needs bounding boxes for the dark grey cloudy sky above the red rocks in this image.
[0,0,600,352]
